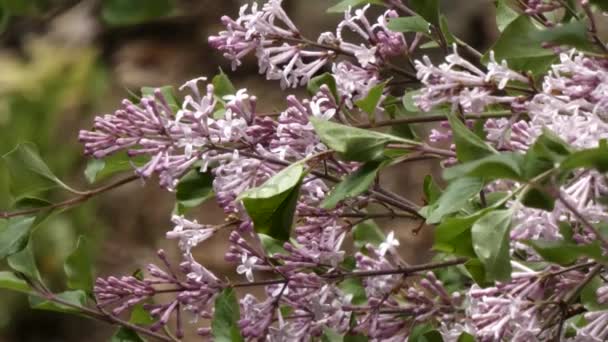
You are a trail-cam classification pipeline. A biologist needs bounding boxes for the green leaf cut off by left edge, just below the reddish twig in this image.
[0,216,36,259]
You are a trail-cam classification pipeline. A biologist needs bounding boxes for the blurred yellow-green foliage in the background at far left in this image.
[0,39,107,329]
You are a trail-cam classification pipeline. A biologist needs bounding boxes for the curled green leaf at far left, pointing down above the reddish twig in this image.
[2,143,74,199]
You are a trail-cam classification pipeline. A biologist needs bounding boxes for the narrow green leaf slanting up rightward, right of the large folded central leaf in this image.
[321,161,384,209]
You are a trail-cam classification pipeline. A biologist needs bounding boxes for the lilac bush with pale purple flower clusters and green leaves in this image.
[2,0,608,341]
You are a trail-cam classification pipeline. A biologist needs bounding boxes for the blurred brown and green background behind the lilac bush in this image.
[0,0,504,341]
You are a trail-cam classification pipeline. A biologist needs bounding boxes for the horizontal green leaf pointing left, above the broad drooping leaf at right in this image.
[443,152,523,182]
